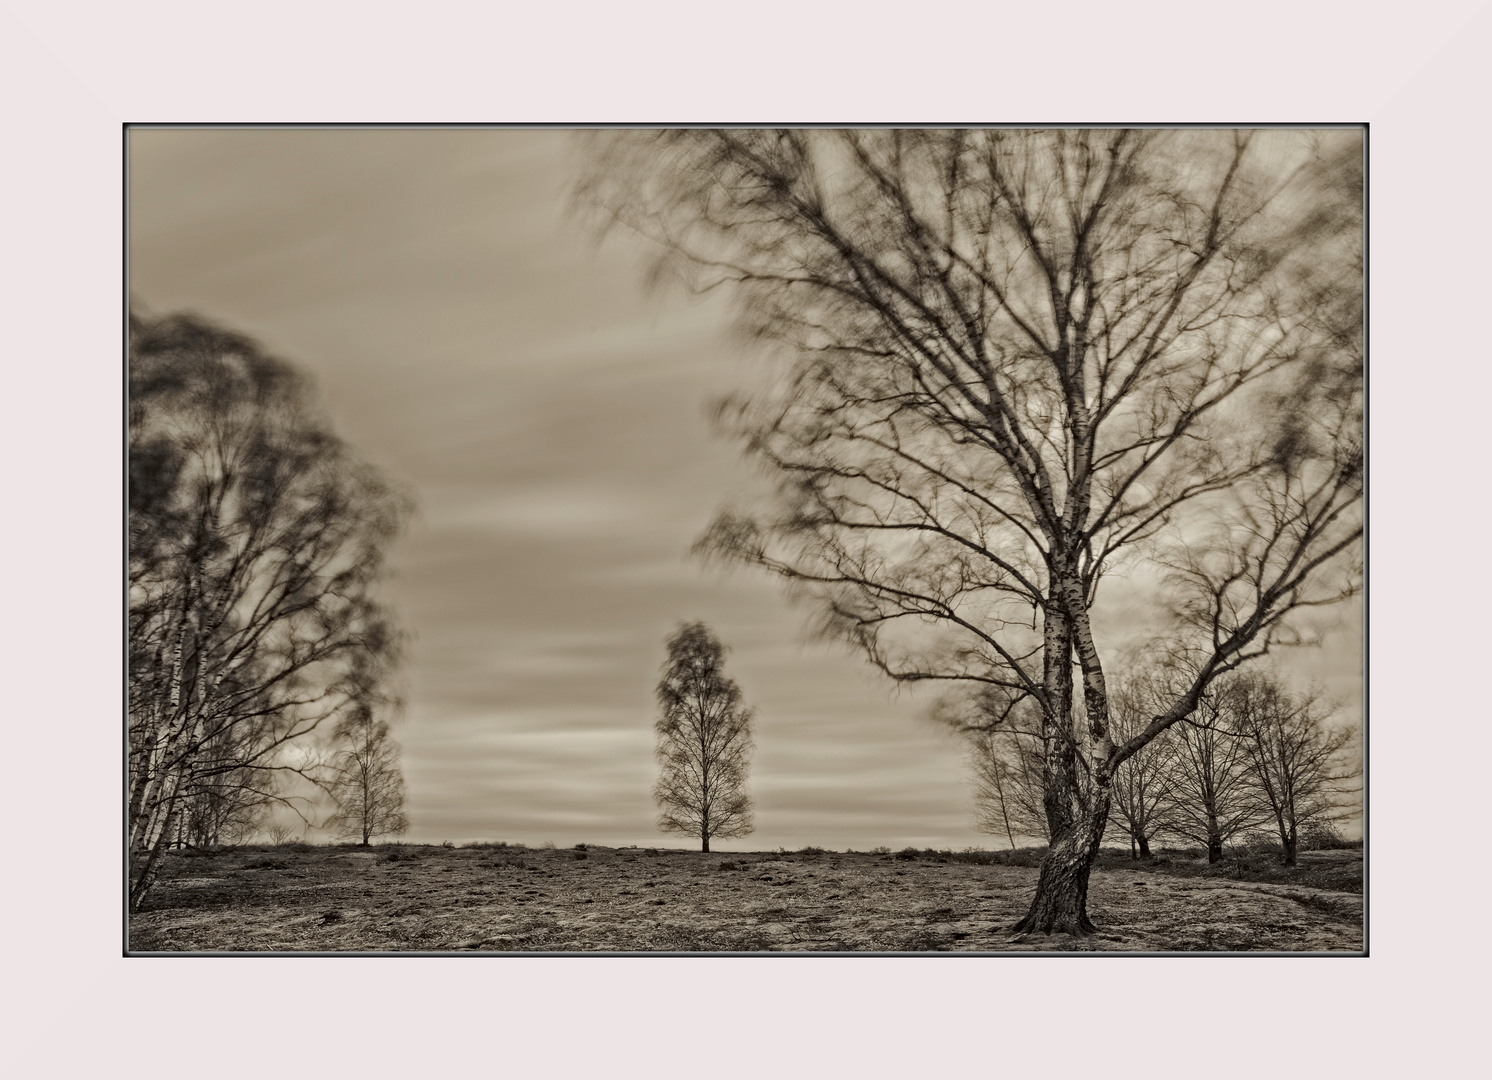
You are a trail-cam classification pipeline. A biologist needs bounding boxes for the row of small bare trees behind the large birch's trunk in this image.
[960,653,1362,865]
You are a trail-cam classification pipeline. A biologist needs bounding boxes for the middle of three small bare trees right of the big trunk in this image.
[1167,680,1268,862]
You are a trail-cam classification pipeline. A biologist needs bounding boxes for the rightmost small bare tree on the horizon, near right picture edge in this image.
[1235,671,1362,867]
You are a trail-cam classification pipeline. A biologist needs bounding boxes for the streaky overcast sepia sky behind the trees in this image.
[130,128,1361,850]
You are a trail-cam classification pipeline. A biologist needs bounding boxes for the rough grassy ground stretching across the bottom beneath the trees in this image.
[128,844,1364,953]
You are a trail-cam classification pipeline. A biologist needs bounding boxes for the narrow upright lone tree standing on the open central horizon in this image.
[653,622,755,852]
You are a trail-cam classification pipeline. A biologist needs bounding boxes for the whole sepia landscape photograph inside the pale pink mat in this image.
[128,124,1368,970]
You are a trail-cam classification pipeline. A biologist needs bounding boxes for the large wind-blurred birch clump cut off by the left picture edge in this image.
[128,316,406,910]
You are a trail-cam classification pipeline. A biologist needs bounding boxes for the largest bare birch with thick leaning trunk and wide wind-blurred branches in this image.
[577,130,1362,934]
